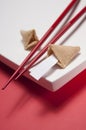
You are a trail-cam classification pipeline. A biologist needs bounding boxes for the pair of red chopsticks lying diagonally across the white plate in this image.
[2,0,86,90]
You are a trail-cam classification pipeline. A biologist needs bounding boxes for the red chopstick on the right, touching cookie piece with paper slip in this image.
[16,7,86,79]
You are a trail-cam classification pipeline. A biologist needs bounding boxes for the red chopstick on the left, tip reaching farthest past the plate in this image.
[2,0,77,90]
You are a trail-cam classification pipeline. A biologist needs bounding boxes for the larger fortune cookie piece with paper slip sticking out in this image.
[48,45,80,68]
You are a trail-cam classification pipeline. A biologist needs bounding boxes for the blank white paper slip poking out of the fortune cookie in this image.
[30,55,58,80]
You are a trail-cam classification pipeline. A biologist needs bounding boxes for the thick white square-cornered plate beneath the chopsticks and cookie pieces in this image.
[0,0,86,91]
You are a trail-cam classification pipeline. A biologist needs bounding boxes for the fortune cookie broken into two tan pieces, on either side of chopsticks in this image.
[21,29,80,68]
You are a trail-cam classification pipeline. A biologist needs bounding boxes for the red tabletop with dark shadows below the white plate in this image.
[0,63,86,130]
